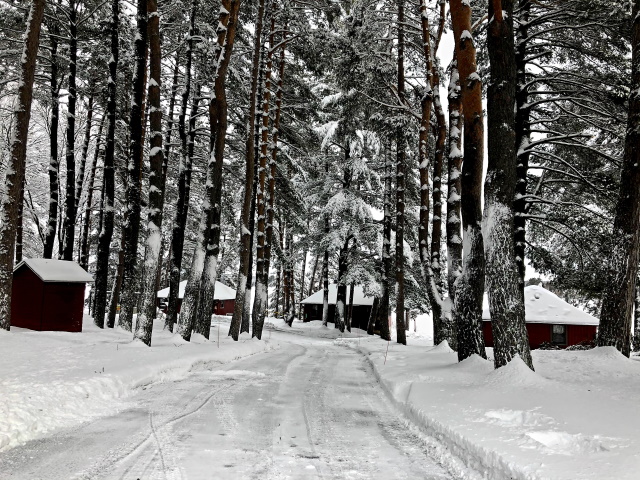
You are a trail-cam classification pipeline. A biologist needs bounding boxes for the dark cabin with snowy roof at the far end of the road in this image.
[300,283,373,330]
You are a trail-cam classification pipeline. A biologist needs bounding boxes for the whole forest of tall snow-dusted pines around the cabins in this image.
[0,0,640,368]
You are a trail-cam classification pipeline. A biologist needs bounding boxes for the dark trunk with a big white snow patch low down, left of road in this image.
[134,0,165,346]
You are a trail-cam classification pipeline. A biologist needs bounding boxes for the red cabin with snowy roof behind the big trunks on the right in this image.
[482,285,599,348]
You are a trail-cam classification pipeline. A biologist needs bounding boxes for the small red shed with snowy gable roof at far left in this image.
[11,258,93,332]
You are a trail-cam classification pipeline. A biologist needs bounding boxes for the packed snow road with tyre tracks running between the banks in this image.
[0,335,451,480]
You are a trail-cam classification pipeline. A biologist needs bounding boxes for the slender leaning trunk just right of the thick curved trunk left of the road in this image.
[229,0,265,341]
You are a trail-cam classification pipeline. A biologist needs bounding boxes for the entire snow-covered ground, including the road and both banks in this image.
[0,318,640,480]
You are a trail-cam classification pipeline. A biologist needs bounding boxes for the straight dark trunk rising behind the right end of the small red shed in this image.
[62,0,82,260]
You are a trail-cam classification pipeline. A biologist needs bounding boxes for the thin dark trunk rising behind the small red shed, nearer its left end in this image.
[42,11,60,258]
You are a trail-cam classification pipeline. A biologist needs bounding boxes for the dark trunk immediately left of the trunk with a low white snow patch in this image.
[118,0,148,332]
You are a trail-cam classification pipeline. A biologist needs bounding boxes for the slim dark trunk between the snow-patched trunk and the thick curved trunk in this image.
[164,0,198,332]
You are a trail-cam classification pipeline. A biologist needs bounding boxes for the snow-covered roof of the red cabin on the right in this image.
[482,285,599,325]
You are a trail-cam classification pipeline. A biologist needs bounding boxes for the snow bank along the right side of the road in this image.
[348,338,640,480]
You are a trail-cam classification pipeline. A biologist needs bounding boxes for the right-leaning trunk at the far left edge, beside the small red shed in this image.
[0,0,45,330]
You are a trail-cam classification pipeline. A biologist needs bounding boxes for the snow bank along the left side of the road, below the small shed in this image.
[0,317,273,451]
